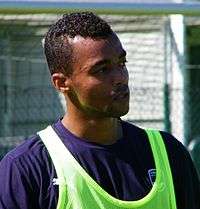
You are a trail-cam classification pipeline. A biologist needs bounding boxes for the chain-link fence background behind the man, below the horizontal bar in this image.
[0,11,200,165]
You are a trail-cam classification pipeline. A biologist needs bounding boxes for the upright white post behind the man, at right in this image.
[170,0,186,143]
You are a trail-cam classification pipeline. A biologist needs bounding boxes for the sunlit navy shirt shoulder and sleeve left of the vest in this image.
[0,132,57,208]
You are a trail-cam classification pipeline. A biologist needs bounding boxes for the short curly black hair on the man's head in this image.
[44,12,113,74]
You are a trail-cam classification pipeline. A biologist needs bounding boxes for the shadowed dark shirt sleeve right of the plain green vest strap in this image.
[162,133,200,209]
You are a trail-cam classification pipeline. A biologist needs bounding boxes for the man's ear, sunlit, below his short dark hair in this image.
[51,73,70,93]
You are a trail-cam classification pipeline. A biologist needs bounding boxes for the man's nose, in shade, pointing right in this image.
[112,66,129,85]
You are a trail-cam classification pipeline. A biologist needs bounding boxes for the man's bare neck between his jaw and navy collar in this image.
[62,114,123,145]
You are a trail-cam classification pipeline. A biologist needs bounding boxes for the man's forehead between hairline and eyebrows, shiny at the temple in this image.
[70,34,124,65]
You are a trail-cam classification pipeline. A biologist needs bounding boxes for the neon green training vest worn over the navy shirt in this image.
[39,126,176,209]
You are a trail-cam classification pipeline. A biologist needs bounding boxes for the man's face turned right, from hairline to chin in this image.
[68,34,129,117]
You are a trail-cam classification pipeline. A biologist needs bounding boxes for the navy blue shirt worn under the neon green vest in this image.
[0,120,200,209]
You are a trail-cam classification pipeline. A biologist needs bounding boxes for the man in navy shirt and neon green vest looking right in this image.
[0,12,200,209]
